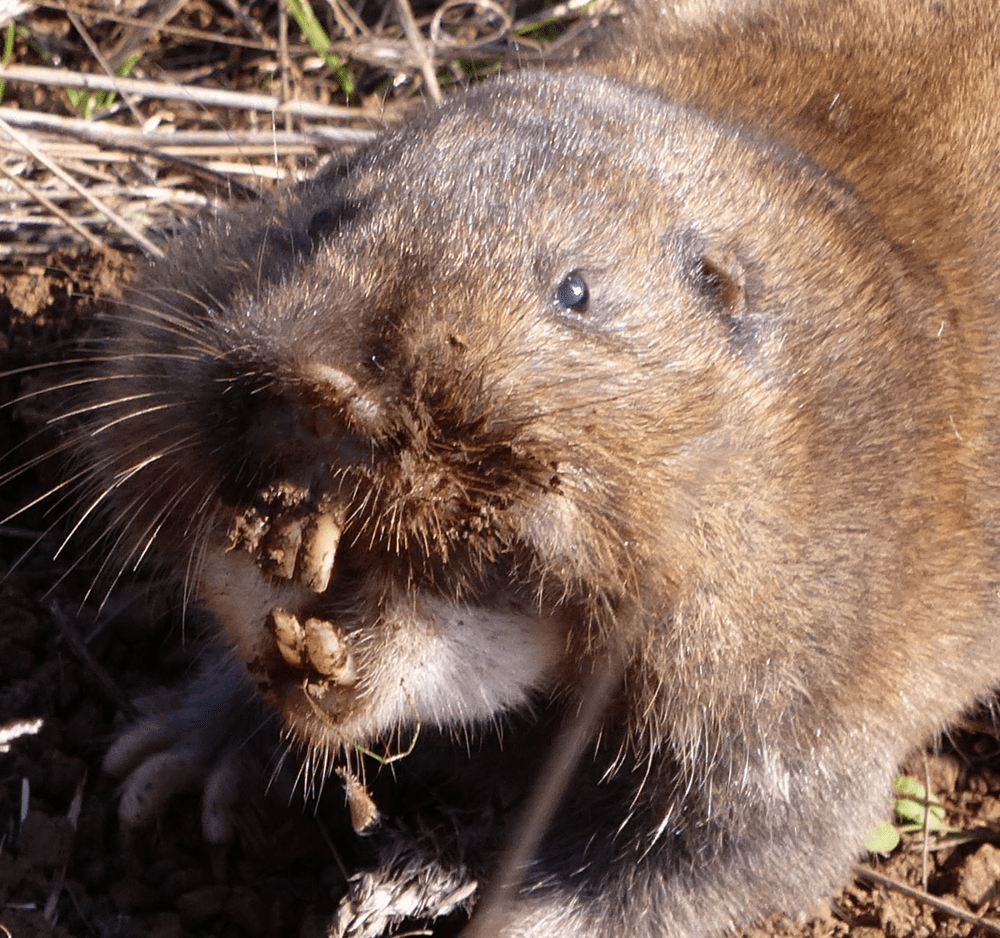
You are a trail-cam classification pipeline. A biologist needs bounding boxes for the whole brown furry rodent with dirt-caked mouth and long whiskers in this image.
[64,0,1000,938]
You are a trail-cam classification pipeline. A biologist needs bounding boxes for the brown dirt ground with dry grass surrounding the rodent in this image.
[0,2,1000,938]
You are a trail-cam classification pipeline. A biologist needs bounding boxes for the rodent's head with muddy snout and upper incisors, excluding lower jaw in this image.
[91,75,928,744]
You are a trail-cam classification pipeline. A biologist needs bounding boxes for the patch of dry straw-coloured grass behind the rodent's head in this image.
[0,0,607,256]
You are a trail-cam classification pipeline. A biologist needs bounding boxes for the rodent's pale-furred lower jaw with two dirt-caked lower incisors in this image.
[198,548,567,744]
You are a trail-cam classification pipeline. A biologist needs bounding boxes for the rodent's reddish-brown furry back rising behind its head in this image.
[591,0,1000,284]
